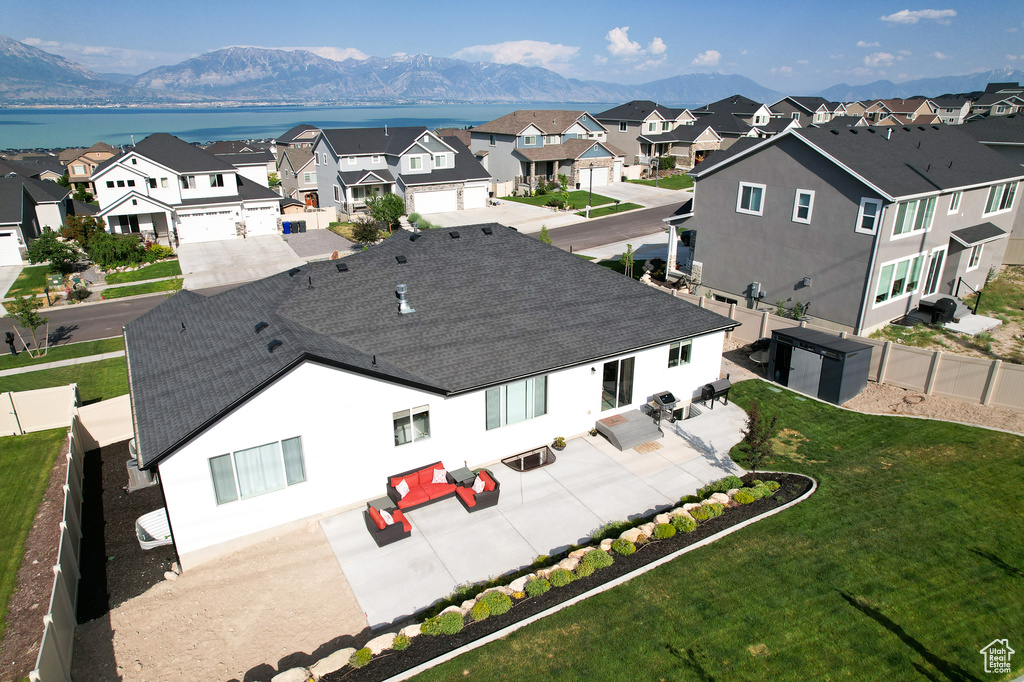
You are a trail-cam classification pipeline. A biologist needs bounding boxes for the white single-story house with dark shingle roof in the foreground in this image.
[124,223,736,570]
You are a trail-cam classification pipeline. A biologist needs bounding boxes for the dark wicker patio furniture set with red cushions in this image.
[362,462,501,547]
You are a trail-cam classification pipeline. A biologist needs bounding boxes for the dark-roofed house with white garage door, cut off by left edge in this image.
[0,175,74,265]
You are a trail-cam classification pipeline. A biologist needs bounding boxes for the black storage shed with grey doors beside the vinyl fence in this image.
[768,327,871,404]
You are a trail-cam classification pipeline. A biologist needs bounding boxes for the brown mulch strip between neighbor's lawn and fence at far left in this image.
[0,437,70,680]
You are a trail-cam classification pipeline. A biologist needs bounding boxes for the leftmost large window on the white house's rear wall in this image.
[210,437,306,505]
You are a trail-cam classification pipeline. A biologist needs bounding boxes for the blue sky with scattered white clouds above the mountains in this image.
[0,0,1024,92]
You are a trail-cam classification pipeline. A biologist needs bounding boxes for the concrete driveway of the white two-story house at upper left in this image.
[178,235,305,290]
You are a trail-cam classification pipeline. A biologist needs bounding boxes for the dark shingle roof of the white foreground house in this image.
[126,223,736,466]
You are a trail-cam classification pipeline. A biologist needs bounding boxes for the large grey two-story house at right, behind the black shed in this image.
[674,126,1024,334]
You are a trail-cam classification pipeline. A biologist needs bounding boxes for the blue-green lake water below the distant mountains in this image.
[0,102,615,150]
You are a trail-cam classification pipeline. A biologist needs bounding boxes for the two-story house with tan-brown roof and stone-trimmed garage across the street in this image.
[469,110,625,189]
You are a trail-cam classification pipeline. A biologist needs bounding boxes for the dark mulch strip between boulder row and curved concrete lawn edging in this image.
[322,473,811,682]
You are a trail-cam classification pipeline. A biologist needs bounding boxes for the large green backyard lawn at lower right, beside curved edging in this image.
[413,381,1024,681]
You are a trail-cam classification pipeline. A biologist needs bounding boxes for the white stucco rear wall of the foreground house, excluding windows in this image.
[159,333,724,568]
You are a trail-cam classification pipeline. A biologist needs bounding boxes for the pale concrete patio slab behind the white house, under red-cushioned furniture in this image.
[321,404,746,627]
